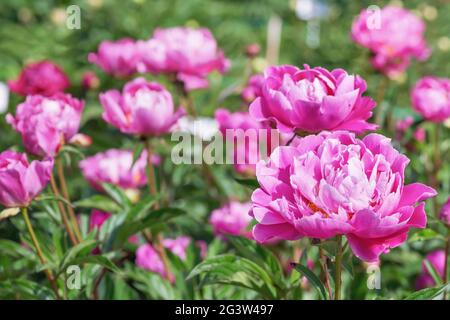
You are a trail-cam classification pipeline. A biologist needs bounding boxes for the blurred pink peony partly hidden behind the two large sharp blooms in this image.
[215,108,276,175]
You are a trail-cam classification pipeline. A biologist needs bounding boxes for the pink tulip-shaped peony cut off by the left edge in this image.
[0,151,53,207]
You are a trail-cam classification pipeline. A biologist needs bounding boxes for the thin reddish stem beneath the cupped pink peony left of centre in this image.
[144,138,170,280]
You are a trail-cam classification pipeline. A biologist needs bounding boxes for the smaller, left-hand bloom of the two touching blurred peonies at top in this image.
[88,38,139,77]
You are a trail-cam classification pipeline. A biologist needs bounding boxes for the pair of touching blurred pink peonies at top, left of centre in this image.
[88,27,229,91]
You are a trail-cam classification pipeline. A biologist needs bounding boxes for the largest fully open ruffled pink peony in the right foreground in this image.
[251,131,436,262]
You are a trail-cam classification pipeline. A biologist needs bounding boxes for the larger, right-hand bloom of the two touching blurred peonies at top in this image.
[151,27,229,91]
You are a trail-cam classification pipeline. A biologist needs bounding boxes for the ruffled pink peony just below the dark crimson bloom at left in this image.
[6,93,84,156]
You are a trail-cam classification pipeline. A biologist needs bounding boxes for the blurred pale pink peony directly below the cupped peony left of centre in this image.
[80,149,155,191]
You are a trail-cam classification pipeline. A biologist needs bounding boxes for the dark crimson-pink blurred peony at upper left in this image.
[8,60,70,96]
